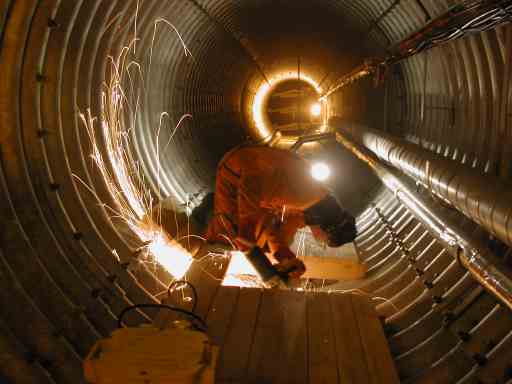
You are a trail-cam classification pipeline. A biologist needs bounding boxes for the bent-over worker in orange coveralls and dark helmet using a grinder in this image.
[201,146,356,278]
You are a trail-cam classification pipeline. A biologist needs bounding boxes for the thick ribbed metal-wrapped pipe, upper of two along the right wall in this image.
[343,126,512,245]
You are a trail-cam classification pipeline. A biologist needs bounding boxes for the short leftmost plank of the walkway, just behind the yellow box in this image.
[206,287,240,345]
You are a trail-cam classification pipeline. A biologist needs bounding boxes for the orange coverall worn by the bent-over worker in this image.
[206,146,327,262]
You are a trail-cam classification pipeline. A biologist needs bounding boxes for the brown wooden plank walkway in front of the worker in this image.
[202,286,399,384]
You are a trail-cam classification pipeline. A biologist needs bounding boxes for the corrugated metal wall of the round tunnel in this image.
[0,0,512,383]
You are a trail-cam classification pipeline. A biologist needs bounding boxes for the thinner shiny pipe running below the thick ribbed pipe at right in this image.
[336,132,512,309]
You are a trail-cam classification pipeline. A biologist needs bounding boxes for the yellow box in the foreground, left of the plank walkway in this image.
[84,326,218,384]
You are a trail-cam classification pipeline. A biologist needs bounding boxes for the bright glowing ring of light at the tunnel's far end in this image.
[252,71,322,138]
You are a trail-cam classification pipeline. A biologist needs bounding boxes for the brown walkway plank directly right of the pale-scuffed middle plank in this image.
[306,293,339,384]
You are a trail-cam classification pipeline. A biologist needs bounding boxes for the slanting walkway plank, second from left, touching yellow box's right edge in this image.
[216,288,262,383]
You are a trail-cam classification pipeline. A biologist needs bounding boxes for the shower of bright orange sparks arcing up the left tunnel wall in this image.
[74,26,193,279]
